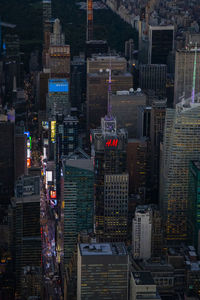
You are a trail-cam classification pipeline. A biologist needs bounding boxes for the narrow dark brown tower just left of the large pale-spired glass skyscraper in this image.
[150,99,167,201]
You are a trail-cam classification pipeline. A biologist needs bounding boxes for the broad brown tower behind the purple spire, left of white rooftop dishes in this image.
[87,55,133,129]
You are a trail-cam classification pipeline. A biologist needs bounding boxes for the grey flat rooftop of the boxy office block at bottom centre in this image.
[79,243,127,256]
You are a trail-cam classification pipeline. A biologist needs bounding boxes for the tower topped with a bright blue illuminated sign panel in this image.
[47,78,70,118]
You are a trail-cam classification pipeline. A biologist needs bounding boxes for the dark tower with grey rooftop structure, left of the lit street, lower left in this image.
[12,176,41,299]
